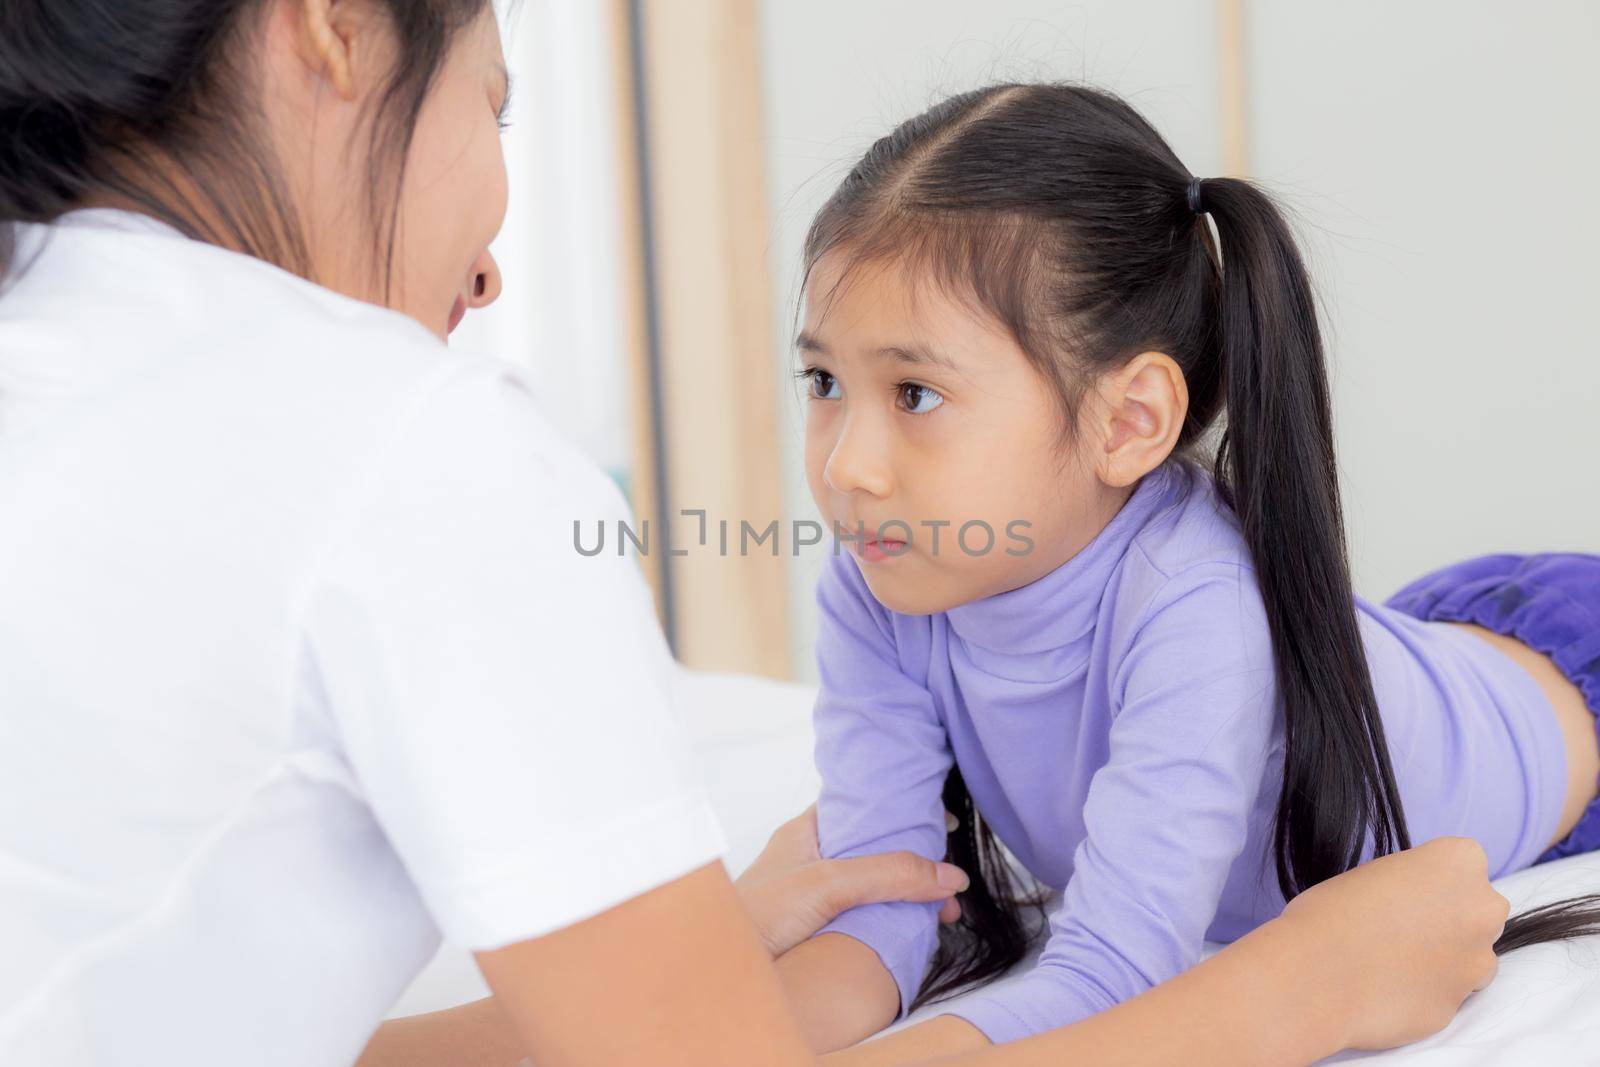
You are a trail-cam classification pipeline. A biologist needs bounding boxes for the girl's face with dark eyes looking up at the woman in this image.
[797,253,1128,614]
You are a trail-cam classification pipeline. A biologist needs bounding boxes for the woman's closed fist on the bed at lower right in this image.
[1282,837,1510,1049]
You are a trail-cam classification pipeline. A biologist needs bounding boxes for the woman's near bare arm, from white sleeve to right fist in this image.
[460,838,1507,1067]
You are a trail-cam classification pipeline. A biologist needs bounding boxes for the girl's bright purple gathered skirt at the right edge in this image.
[1387,552,1600,862]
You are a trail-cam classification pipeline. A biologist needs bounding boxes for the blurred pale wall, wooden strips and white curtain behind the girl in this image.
[453,0,1600,680]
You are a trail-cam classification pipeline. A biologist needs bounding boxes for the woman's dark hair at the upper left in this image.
[0,0,488,298]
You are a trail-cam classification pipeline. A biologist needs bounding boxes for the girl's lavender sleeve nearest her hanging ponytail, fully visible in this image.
[949,571,1277,1041]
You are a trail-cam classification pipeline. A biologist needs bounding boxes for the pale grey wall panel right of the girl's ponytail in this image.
[1248,0,1600,597]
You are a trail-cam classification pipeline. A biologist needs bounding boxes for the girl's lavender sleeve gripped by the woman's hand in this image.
[814,555,952,1013]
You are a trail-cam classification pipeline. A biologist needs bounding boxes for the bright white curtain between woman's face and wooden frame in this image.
[451,0,632,480]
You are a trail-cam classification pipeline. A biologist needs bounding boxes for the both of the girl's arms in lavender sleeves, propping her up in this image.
[779,558,1275,1053]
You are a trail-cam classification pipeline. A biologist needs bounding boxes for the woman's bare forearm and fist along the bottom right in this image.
[822,838,1509,1067]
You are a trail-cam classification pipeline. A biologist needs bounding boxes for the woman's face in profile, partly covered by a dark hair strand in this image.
[269,0,510,339]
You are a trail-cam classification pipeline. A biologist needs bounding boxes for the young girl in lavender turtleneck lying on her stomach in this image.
[781,85,1600,1062]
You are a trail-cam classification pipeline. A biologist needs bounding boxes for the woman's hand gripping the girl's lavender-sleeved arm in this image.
[734,805,968,957]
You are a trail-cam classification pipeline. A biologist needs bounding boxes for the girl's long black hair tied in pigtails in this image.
[805,85,1600,1005]
